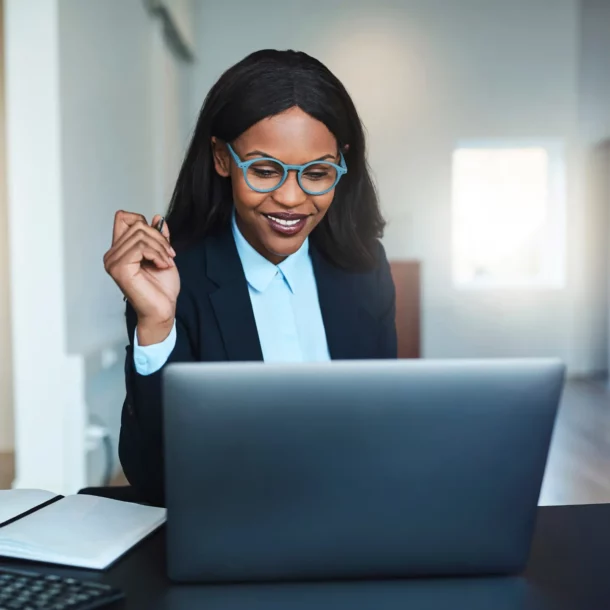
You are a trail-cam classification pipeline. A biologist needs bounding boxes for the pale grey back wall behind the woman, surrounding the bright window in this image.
[193,0,589,371]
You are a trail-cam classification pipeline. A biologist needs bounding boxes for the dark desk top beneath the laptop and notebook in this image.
[5,504,610,610]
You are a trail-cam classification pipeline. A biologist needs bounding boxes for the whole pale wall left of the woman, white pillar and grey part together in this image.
[6,0,194,493]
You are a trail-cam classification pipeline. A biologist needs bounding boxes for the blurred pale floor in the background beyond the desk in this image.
[0,381,610,505]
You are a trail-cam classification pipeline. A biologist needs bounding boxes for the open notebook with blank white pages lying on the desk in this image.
[0,489,167,570]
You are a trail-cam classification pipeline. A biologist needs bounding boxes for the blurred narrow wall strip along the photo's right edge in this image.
[579,0,610,370]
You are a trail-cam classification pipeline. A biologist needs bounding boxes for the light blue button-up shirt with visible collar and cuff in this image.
[134,217,330,375]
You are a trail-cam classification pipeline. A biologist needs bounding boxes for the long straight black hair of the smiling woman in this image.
[167,50,385,270]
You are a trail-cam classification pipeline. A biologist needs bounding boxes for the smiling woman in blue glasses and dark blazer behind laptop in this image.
[104,51,396,504]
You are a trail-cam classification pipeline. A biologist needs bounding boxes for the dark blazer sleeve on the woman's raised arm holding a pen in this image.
[119,291,197,506]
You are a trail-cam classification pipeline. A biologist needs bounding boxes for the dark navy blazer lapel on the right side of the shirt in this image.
[311,248,367,360]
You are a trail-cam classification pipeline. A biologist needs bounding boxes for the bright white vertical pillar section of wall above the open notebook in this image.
[5,0,85,493]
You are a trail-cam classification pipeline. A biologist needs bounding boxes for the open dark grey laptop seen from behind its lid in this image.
[163,360,564,583]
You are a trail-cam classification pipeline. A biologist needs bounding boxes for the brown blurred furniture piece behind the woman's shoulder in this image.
[390,261,421,358]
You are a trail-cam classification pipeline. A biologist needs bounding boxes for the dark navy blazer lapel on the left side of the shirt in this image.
[206,229,263,361]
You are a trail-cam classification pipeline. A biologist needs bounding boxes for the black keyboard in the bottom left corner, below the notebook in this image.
[0,566,125,610]
